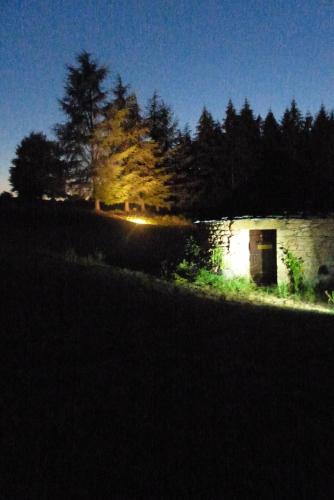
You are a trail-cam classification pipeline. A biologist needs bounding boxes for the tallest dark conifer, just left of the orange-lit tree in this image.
[56,51,107,204]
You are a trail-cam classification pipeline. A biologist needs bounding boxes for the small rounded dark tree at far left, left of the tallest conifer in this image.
[9,132,65,200]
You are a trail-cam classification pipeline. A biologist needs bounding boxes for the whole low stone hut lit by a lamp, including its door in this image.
[197,214,334,286]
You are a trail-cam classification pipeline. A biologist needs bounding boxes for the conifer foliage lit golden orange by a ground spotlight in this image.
[91,107,170,211]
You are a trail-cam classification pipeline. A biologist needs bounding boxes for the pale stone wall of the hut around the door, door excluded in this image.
[199,217,334,283]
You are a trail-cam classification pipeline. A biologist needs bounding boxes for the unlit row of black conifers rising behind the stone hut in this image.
[168,100,334,216]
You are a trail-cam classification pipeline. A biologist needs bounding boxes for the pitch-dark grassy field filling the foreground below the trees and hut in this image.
[0,202,334,500]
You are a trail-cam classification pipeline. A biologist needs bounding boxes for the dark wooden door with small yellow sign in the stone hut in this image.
[249,229,277,285]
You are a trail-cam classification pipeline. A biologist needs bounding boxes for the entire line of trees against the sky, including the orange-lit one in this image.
[10,52,334,217]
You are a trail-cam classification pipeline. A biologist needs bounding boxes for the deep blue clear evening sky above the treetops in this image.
[0,0,334,191]
